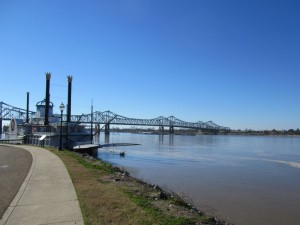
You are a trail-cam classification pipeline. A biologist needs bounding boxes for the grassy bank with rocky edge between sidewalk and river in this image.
[50,149,224,225]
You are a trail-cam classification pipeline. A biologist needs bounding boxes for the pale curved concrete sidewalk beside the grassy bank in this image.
[0,146,84,225]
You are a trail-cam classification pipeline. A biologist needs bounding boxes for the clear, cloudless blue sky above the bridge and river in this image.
[0,0,300,129]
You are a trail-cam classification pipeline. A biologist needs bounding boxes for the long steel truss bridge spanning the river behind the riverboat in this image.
[0,102,230,133]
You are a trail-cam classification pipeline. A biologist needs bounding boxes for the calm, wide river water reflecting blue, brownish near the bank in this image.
[98,133,300,225]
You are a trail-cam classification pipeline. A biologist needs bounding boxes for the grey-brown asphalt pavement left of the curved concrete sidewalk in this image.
[0,145,32,218]
